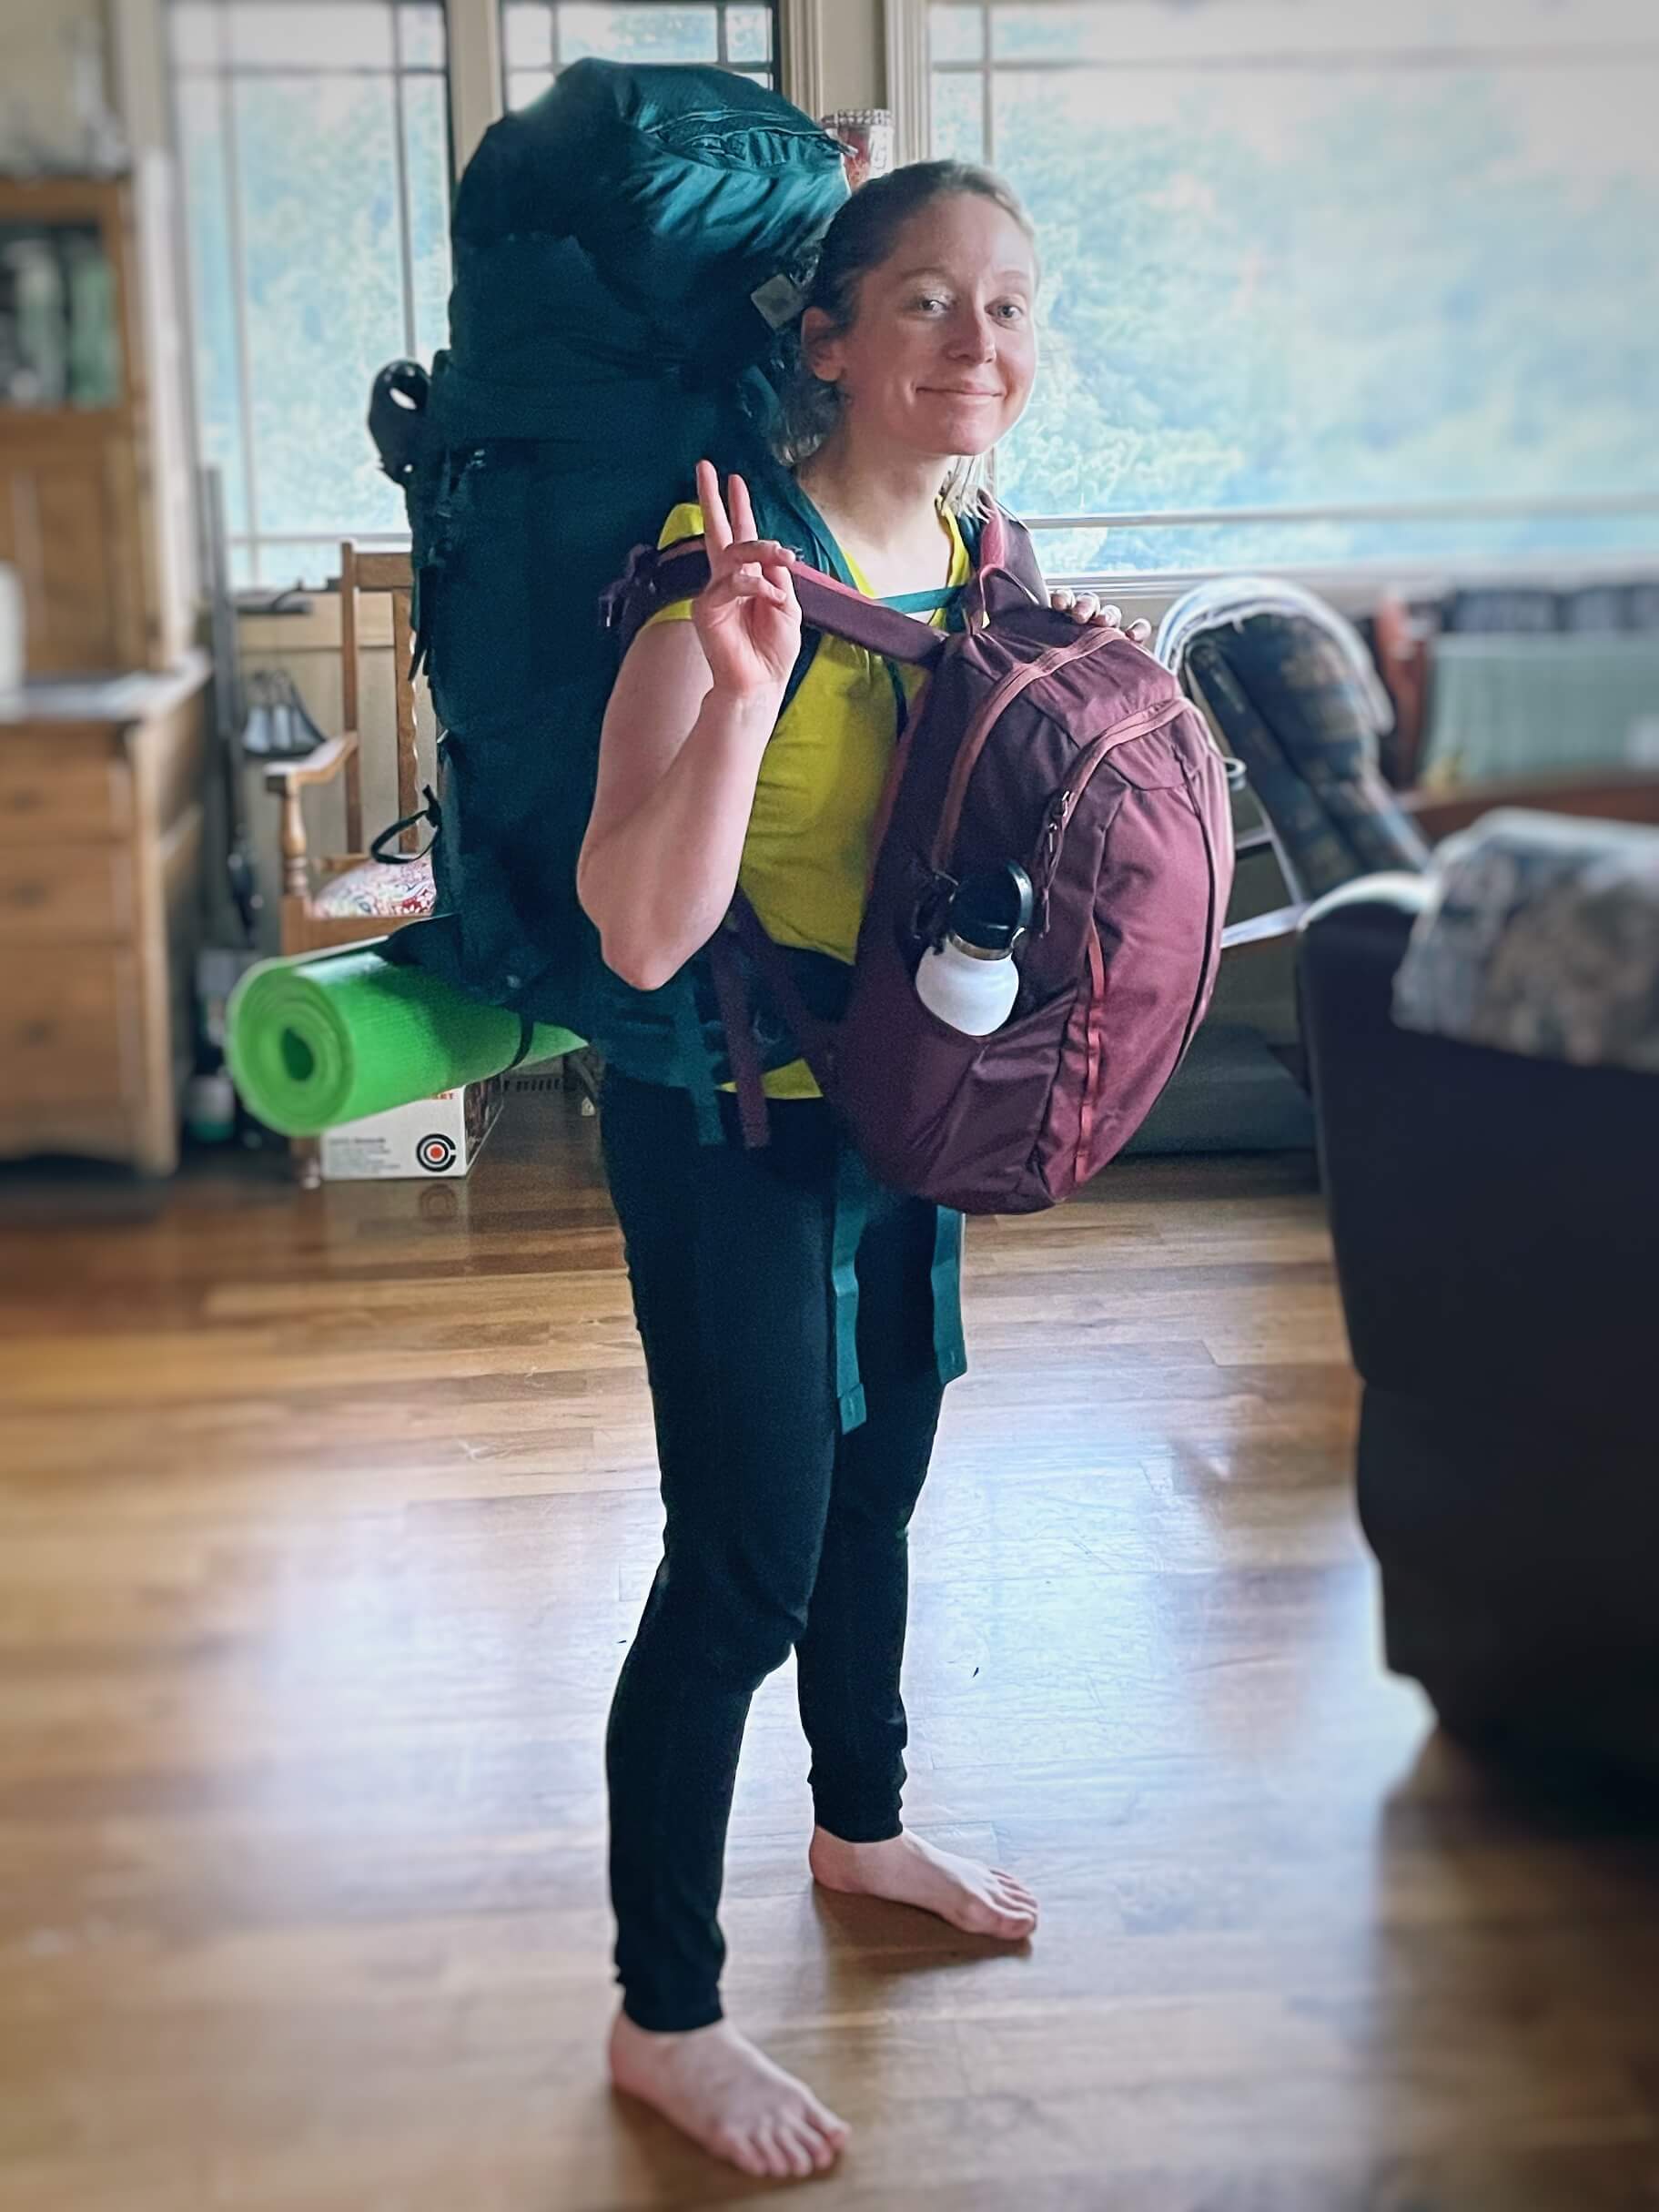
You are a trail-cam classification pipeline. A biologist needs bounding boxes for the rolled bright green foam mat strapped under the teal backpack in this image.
[226,945,582,1137]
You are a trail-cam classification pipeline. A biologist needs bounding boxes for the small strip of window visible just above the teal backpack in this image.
[502,0,776,108]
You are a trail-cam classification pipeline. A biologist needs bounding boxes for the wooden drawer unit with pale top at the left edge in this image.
[0,654,207,1174]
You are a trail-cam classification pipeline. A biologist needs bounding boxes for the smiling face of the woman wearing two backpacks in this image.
[803,192,1037,460]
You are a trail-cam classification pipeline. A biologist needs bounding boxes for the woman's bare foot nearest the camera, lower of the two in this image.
[611,2013,847,2181]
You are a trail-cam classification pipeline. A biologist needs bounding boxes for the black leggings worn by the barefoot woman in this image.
[600,1075,940,2031]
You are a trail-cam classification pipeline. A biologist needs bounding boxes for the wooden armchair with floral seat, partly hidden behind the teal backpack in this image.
[266,540,433,956]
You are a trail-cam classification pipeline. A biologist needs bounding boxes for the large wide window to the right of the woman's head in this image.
[928,0,1659,573]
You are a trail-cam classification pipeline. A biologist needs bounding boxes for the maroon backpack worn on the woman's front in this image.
[623,509,1232,1214]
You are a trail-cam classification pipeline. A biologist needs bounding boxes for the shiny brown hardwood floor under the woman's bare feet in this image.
[0,1100,1659,2212]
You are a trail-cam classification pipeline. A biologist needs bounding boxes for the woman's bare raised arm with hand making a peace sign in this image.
[577,462,801,991]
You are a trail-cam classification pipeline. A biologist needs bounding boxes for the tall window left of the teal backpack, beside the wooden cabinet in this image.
[168,0,449,584]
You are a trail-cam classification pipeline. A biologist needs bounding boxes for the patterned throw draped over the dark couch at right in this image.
[1393,807,1659,1073]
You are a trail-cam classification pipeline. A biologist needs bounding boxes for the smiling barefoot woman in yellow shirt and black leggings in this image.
[580,161,1146,2176]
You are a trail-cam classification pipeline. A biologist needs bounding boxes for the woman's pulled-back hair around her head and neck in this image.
[772,161,1037,515]
